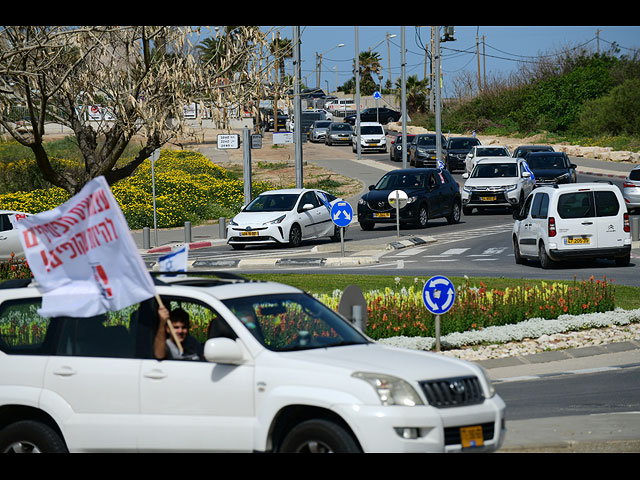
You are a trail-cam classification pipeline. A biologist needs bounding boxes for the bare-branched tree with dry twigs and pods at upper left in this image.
[0,26,266,194]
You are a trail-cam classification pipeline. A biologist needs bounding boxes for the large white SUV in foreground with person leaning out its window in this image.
[0,272,505,452]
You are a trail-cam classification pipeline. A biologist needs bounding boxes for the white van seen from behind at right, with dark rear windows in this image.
[513,183,631,268]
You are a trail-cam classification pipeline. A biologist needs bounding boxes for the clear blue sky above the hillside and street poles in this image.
[263,25,640,98]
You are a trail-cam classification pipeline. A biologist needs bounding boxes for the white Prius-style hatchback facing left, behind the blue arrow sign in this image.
[227,188,341,249]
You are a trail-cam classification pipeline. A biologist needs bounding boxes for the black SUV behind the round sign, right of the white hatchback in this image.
[358,168,460,230]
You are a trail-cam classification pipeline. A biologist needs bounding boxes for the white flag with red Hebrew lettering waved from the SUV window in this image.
[17,177,155,318]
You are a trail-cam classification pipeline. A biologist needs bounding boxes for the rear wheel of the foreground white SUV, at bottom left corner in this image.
[0,420,67,453]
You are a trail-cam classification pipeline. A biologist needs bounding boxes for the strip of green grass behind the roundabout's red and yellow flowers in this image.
[245,273,640,310]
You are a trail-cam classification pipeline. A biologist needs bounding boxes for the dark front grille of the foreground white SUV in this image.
[420,377,484,408]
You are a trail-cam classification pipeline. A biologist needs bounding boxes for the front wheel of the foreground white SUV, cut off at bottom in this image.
[280,420,361,453]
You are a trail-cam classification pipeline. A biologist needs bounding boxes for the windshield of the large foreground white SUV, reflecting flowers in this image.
[224,293,368,352]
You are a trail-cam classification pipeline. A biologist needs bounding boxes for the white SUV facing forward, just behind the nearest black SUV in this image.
[462,157,535,215]
